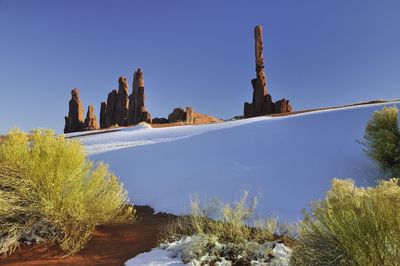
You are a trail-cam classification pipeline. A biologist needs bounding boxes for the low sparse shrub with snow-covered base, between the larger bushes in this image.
[162,192,291,265]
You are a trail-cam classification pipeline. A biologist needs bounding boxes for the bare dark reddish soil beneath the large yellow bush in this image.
[0,206,175,266]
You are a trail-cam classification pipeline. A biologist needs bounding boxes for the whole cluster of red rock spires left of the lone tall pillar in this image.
[64,68,222,133]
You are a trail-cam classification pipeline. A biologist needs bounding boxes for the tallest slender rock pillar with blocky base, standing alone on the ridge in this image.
[244,25,292,118]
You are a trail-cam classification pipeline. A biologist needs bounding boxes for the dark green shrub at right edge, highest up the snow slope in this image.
[364,106,400,178]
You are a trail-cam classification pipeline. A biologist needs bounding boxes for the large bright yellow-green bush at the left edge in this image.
[0,130,134,254]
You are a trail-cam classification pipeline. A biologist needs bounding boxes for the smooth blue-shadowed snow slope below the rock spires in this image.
[72,103,398,221]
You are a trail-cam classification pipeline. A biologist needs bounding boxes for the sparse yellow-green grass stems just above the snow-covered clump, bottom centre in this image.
[161,191,292,245]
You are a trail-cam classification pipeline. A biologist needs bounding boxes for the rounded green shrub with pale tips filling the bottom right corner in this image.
[292,179,400,265]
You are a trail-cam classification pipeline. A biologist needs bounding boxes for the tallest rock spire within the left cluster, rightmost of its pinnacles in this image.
[127,68,151,125]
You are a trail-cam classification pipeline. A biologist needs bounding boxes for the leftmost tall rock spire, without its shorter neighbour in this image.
[64,88,84,133]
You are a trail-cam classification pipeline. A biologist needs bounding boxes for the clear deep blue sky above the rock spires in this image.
[0,0,400,133]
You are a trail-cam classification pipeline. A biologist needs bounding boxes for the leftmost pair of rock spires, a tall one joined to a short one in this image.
[64,88,99,133]
